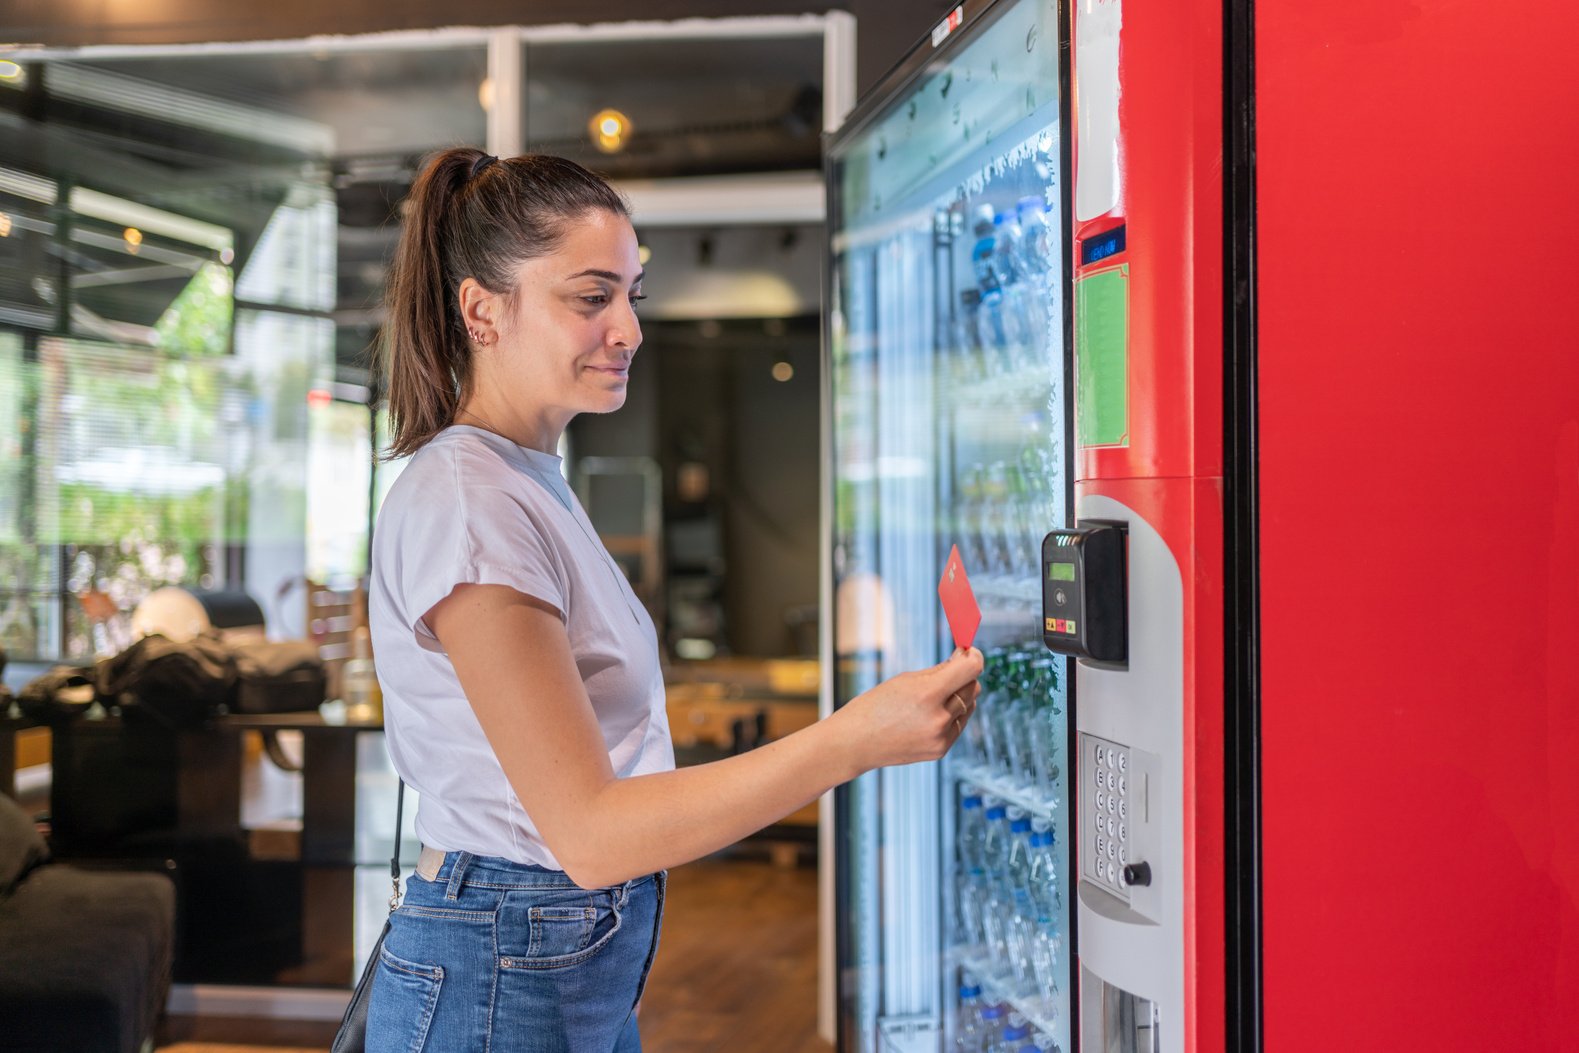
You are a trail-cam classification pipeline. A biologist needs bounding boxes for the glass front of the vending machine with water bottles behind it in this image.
[824,0,1075,1053]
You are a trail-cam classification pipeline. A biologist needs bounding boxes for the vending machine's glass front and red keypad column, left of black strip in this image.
[827,0,1225,1053]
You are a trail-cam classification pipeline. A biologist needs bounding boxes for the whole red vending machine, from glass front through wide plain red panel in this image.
[827,0,1579,1053]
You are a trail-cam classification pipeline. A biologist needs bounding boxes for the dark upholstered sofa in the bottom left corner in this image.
[0,793,175,1053]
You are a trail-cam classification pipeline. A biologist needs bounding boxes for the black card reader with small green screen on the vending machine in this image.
[1042,519,1129,669]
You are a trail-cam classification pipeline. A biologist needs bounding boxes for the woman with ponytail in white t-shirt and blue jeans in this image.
[368,150,982,1053]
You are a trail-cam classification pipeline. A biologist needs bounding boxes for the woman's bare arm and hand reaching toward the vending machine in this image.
[426,586,982,887]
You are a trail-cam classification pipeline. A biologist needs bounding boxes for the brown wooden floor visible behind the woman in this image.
[158,859,832,1053]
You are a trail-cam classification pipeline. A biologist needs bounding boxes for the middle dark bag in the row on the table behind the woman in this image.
[98,633,237,731]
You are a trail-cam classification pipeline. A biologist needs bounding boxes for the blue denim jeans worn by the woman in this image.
[366,853,668,1053]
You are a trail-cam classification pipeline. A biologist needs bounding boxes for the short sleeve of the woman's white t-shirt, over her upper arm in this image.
[392,463,568,652]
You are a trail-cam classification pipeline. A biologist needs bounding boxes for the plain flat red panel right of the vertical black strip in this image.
[1255,2,1579,1053]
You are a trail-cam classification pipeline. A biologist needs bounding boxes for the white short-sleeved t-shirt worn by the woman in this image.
[368,425,674,870]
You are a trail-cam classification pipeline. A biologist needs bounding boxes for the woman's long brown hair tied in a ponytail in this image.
[379,147,630,456]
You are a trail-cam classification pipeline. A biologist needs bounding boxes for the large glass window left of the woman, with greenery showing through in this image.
[0,45,486,661]
